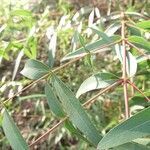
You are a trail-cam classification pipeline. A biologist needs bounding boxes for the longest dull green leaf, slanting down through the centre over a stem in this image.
[52,76,102,145]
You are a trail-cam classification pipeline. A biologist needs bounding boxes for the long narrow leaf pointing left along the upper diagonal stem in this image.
[62,36,120,61]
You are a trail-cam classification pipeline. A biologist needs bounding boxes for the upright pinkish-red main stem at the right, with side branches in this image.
[121,12,130,119]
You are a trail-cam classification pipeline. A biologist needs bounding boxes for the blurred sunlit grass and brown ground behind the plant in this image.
[0,0,150,150]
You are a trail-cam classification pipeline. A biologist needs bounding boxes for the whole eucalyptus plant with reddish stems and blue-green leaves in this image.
[2,8,150,150]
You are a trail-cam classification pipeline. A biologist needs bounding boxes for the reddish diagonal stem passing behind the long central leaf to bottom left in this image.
[30,80,122,147]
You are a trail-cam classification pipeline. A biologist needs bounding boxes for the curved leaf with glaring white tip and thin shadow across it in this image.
[76,72,118,97]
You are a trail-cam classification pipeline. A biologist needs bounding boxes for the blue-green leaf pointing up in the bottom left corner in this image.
[2,109,29,150]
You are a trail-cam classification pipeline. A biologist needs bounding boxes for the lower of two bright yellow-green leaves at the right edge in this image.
[128,36,150,52]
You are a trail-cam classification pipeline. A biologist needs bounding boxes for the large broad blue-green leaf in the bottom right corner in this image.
[98,107,150,150]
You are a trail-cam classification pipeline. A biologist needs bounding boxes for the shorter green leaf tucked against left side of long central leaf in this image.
[45,83,65,117]
